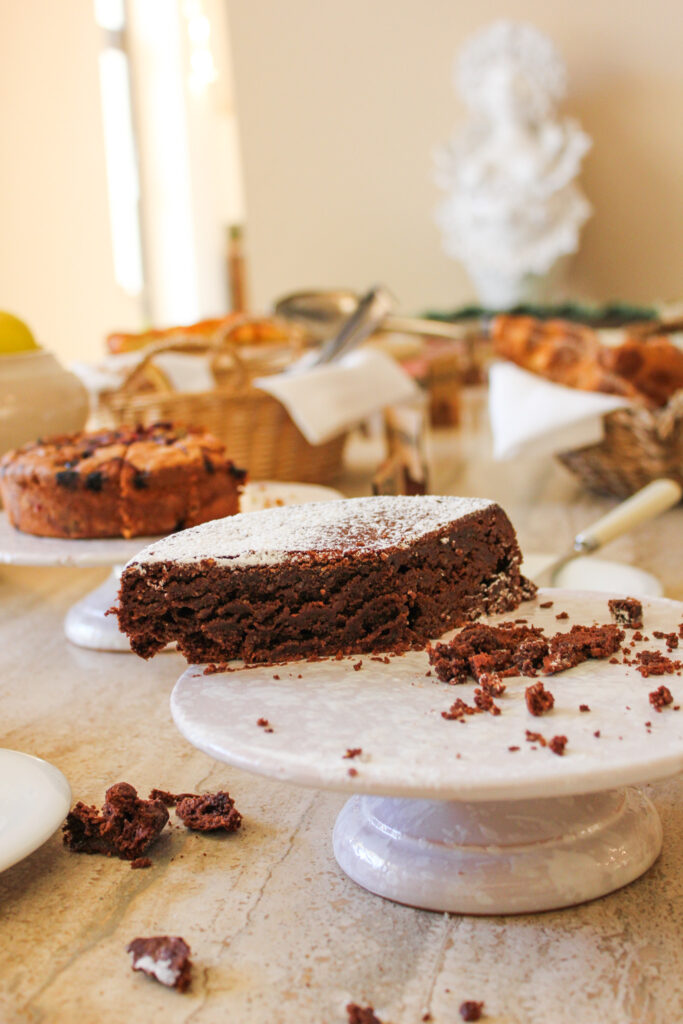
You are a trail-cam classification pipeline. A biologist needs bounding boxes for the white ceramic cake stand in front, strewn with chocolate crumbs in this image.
[171,590,683,913]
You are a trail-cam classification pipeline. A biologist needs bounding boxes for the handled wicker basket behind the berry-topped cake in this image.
[100,322,346,483]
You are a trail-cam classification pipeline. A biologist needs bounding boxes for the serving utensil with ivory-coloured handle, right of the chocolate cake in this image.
[533,478,683,587]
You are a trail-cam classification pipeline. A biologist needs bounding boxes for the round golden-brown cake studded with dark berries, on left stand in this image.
[0,423,247,538]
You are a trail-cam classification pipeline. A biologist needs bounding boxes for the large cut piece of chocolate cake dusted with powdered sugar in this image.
[118,495,536,663]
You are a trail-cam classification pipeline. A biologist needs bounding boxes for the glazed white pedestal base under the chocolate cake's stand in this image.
[333,788,661,914]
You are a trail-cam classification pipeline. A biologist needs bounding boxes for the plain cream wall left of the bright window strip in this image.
[0,0,141,360]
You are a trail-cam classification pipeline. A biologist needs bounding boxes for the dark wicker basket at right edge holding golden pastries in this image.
[558,391,683,498]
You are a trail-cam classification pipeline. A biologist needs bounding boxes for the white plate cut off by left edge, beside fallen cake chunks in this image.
[0,749,71,871]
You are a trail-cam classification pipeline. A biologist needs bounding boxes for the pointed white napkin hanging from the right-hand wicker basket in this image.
[488,362,631,459]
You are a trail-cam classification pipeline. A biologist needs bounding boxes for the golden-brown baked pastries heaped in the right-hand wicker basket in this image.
[490,314,683,409]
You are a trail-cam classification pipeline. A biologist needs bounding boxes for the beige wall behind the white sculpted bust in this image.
[226,0,683,308]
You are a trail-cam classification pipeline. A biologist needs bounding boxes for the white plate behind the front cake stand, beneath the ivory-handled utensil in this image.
[522,552,664,597]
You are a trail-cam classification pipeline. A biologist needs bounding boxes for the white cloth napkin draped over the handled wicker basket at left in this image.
[253,347,422,444]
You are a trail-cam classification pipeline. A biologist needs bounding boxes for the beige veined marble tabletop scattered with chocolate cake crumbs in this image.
[0,419,683,1024]
